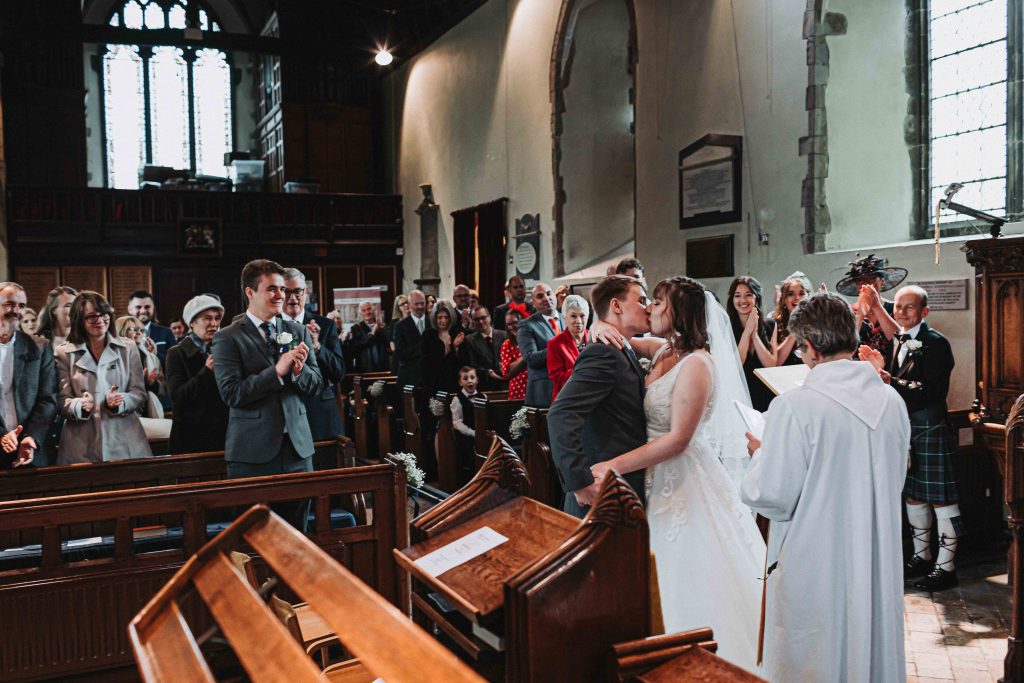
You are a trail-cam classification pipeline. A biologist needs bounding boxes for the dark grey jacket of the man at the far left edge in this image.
[0,330,57,468]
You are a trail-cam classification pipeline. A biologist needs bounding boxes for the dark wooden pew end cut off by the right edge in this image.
[972,395,1024,681]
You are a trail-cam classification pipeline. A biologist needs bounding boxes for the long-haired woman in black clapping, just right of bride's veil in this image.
[725,275,775,413]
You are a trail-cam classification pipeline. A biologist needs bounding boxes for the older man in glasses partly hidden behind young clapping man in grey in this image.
[282,268,345,441]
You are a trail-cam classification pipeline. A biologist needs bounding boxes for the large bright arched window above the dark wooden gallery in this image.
[102,0,231,188]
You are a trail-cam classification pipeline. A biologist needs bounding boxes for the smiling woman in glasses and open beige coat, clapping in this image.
[54,292,153,465]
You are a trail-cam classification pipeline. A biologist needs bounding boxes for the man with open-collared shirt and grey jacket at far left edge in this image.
[0,283,57,469]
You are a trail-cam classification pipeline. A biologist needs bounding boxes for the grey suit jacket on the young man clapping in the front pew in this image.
[213,315,324,465]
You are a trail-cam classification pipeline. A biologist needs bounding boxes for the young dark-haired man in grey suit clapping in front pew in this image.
[213,259,324,531]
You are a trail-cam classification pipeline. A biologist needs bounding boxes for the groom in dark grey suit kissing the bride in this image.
[548,275,650,517]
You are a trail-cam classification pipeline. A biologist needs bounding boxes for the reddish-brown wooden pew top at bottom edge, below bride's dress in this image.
[608,629,764,683]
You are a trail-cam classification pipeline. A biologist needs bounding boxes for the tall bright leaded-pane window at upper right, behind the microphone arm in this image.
[928,0,1012,222]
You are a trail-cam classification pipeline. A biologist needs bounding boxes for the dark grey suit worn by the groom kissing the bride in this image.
[548,344,647,517]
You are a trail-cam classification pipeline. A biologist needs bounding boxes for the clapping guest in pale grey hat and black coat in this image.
[167,294,227,455]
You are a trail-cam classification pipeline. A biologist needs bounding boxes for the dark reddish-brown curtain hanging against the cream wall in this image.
[452,199,508,307]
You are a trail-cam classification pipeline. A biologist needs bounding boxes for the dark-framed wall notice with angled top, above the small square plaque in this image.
[679,133,743,229]
